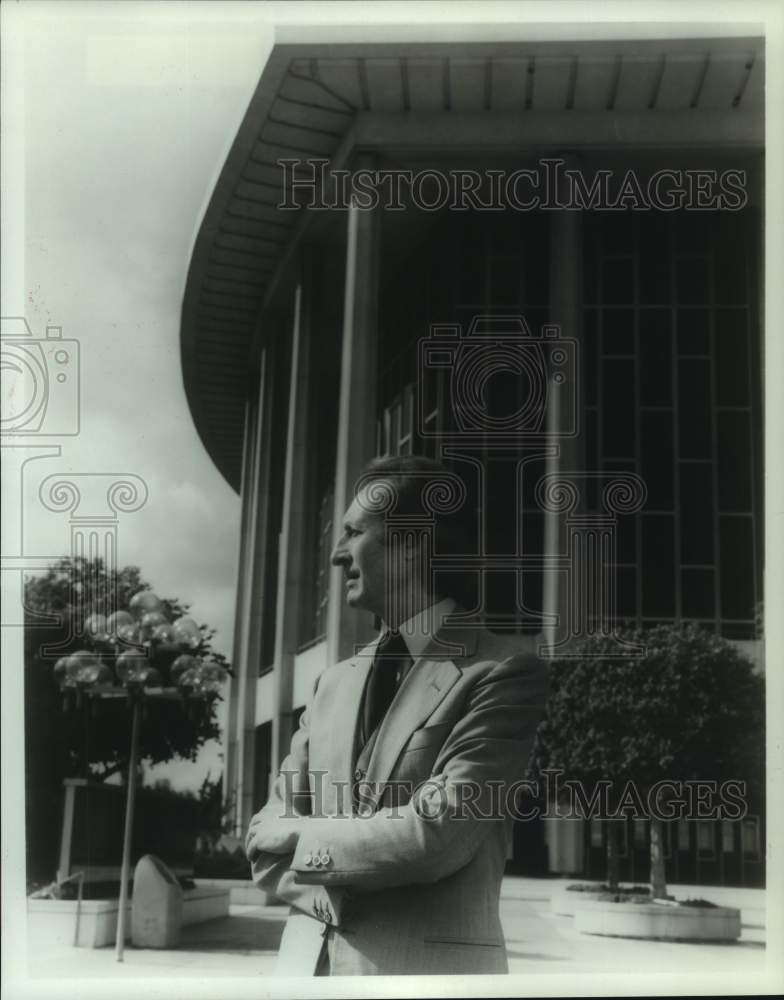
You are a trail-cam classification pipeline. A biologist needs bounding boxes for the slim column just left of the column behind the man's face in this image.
[271,254,313,775]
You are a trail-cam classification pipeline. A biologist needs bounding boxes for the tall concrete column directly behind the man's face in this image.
[327,157,380,663]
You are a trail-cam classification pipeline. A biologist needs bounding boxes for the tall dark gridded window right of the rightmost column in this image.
[583,211,761,638]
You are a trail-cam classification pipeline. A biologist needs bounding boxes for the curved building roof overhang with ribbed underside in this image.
[181,24,764,490]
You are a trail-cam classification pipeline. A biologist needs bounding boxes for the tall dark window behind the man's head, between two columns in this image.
[377,212,549,631]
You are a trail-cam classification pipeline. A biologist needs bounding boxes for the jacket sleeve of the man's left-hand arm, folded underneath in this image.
[250,681,344,926]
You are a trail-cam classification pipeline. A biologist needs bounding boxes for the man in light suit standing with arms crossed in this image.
[246,456,548,975]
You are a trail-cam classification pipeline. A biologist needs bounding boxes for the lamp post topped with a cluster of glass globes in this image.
[54,590,230,962]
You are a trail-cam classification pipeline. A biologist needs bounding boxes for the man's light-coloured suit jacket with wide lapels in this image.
[252,623,549,975]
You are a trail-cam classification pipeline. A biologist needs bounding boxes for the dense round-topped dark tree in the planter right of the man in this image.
[531,625,765,899]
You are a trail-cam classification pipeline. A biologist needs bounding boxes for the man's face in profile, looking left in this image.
[332,489,389,618]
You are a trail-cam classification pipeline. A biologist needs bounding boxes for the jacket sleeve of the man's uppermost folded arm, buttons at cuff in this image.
[291,656,549,892]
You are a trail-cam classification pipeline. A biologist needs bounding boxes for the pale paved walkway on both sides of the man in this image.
[23,878,765,980]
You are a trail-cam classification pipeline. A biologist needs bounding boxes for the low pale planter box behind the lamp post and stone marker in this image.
[27,886,230,948]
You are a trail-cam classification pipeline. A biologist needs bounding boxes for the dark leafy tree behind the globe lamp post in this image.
[24,557,225,878]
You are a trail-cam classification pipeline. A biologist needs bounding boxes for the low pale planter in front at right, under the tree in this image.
[574,893,740,941]
